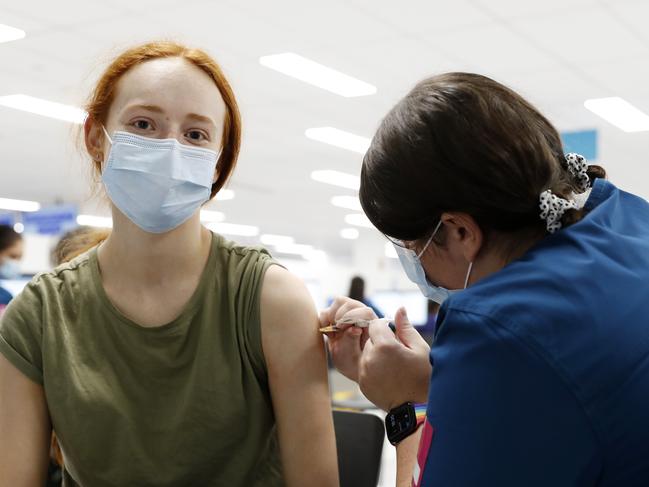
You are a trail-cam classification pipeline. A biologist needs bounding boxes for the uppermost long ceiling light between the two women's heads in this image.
[259,52,376,97]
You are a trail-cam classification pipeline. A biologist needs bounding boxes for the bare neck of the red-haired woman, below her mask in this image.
[98,210,212,284]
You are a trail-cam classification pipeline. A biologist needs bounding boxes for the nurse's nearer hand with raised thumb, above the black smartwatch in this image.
[358,308,432,411]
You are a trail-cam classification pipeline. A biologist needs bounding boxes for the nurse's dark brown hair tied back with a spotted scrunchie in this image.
[360,73,606,246]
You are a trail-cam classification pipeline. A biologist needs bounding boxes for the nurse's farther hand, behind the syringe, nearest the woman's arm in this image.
[320,296,376,382]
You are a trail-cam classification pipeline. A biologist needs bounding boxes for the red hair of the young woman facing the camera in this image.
[85,41,241,197]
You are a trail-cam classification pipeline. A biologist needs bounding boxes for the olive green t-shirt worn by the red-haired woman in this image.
[0,235,284,487]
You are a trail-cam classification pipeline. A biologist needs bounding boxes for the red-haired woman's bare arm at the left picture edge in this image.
[0,354,51,487]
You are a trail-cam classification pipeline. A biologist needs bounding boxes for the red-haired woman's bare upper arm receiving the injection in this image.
[261,266,338,486]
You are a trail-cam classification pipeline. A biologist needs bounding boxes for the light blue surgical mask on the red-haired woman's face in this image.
[101,129,219,233]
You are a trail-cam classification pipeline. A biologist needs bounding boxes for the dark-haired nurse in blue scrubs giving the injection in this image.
[321,73,649,487]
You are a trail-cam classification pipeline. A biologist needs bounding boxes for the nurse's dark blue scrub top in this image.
[415,180,649,487]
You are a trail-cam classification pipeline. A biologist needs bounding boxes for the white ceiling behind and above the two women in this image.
[0,0,649,260]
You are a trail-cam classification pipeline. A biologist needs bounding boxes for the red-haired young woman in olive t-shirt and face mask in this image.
[0,42,338,487]
